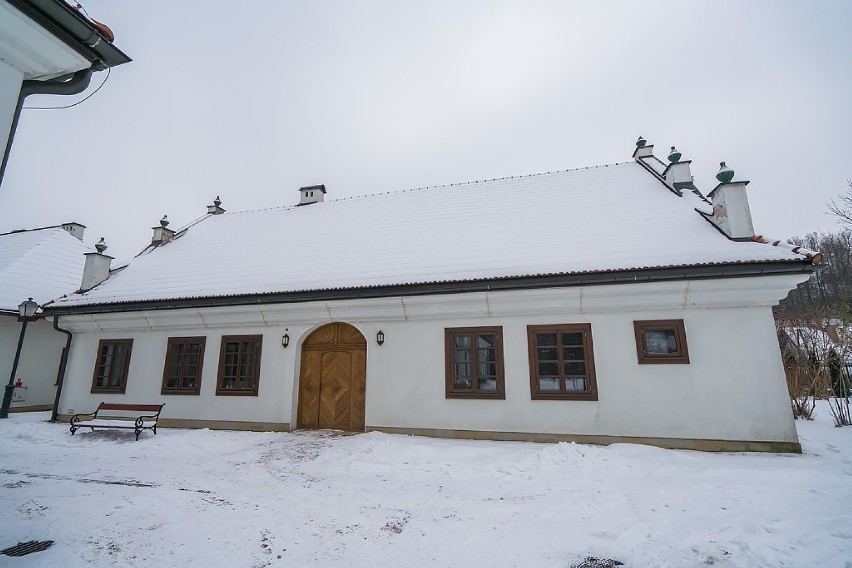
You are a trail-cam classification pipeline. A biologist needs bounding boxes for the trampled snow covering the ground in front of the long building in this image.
[0,407,852,568]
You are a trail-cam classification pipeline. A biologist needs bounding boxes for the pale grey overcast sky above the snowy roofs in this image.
[0,0,852,261]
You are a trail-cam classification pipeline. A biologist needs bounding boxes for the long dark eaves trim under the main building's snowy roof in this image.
[44,260,815,315]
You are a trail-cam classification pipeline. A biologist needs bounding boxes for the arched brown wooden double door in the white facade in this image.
[296,323,367,432]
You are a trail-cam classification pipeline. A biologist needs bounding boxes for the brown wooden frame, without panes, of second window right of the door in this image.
[527,323,598,401]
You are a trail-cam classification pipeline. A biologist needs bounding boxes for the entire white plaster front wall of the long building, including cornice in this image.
[51,276,804,442]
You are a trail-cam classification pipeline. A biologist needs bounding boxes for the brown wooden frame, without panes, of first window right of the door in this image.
[444,326,506,400]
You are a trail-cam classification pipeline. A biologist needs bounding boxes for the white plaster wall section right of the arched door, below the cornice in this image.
[367,308,797,441]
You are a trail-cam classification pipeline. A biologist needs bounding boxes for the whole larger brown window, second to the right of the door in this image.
[527,323,598,400]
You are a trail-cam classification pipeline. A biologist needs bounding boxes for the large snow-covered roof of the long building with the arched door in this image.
[51,162,805,307]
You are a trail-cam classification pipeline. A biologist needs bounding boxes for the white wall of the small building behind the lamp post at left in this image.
[0,316,66,409]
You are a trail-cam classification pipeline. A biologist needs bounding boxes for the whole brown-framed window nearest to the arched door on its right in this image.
[445,327,506,399]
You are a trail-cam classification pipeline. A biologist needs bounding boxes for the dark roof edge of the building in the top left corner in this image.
[8,0,131,71]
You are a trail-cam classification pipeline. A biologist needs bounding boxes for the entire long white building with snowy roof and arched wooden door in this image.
[46,140,819,451]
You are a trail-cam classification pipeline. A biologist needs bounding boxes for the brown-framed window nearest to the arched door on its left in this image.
[216,335,263,396]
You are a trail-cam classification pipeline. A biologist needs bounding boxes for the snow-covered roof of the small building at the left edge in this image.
[0,227,91,313]
